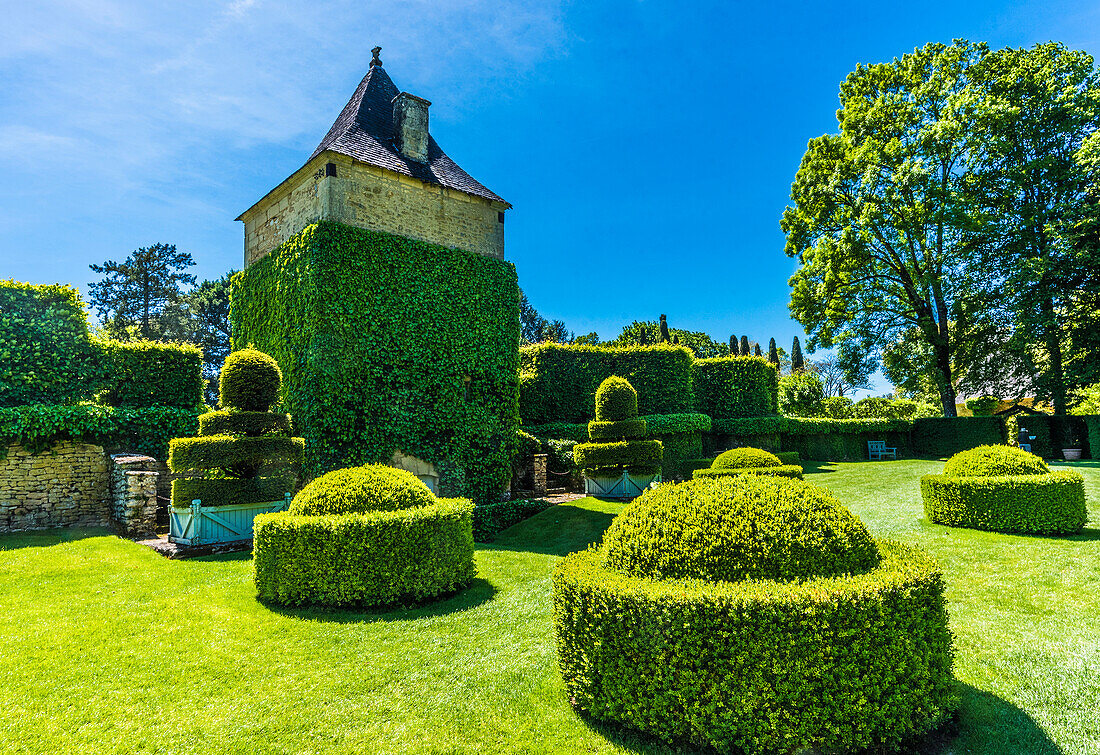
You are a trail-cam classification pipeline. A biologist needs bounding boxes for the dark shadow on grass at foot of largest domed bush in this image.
[578,682,1064,755]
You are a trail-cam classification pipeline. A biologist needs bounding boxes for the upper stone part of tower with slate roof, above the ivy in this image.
[237,47,512,267]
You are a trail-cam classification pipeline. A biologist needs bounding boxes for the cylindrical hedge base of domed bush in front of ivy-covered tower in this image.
[253,499,476,606]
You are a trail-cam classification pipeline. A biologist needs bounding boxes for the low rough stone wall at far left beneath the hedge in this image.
[0,441,108,533]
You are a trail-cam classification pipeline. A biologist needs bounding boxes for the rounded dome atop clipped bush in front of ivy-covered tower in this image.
[288,464,437,515]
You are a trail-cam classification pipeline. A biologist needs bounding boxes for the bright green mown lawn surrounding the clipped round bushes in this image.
[0,461,1100,755]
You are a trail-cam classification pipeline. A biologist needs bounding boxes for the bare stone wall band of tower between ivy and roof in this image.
[242,152,506,266]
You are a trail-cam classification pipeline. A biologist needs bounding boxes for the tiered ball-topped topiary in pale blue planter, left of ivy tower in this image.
[168,349,305,508]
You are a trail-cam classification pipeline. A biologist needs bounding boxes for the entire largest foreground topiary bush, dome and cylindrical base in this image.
[553,478,956,754]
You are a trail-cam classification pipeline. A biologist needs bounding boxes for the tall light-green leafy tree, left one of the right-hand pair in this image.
[782,42,988,416]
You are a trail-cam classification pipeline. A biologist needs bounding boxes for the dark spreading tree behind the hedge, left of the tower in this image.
[89,243,195,338]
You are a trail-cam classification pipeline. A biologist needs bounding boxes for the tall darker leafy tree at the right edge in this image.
[969,42,1100,414]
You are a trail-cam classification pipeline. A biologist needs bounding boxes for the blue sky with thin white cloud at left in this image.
[0,0,1100,396]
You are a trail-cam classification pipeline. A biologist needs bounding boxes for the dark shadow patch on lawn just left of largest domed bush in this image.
[482,499,623,556]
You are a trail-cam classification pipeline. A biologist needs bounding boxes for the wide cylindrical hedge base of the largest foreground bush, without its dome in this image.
[553,539,957,755]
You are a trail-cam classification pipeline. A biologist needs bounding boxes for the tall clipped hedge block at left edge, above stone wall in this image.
[0,281,107,407]
